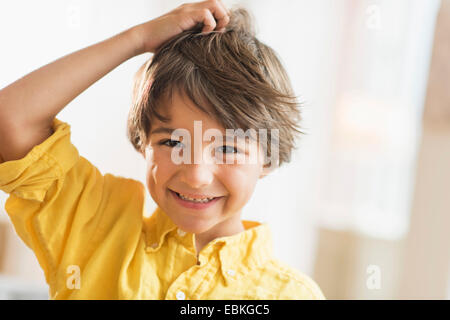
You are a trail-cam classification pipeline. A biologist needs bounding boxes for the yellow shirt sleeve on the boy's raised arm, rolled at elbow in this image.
[0,119,142,295]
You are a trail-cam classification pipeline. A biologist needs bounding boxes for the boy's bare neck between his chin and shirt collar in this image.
[195,214,245,255]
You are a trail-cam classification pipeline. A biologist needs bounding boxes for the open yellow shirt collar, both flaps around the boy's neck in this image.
[144,207,273,282]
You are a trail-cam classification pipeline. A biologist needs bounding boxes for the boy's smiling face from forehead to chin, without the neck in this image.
[145,93,268,235]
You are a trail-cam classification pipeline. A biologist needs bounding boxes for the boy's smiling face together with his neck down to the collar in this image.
[146,89,264,252]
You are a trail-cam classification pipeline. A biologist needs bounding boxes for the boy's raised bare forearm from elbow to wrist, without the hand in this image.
[0,28,140,161]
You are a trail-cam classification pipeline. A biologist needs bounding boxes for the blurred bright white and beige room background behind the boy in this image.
[0,0,450,299]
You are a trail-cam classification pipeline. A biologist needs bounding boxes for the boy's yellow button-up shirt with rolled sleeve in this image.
[0,119,324,300]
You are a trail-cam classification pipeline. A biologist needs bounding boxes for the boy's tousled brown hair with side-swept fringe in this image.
[127,8,303,166]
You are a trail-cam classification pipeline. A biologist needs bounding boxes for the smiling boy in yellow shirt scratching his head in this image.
[0,1,324,300]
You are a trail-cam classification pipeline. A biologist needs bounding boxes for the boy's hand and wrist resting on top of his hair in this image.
[130,0,230,53]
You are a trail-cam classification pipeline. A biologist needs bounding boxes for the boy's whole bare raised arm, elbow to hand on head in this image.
[0,0,229,161]
